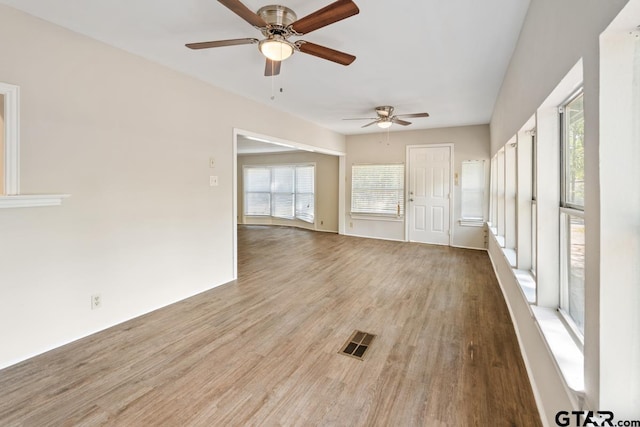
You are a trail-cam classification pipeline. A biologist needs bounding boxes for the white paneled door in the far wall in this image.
[407,146,451,245]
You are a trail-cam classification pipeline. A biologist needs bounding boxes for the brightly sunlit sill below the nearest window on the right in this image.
[531,306,584,396]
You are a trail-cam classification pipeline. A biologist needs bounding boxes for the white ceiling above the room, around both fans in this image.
[0,0,529,135]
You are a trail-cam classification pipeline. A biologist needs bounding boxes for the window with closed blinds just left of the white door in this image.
[351,164,404,216]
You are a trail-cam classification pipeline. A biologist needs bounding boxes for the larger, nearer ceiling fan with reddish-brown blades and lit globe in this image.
[186,0,360,76]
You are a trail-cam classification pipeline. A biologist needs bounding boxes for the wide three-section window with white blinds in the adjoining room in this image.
[244,165,315,223]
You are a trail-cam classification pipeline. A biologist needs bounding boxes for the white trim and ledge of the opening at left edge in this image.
[0,82,70,209]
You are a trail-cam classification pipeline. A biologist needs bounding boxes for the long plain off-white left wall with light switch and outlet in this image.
[0,6,345,367]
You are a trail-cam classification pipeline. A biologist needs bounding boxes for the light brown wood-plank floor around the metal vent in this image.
[0,227,541,427]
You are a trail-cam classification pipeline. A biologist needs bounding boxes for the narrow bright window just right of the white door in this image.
[460,160,484,223]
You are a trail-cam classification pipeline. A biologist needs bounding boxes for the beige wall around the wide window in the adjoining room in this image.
[238,152,338,233]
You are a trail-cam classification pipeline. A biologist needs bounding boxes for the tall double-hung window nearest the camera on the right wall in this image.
[560,92,585,334]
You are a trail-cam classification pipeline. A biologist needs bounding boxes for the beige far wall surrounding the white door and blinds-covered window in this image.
[342,125,490,248]
